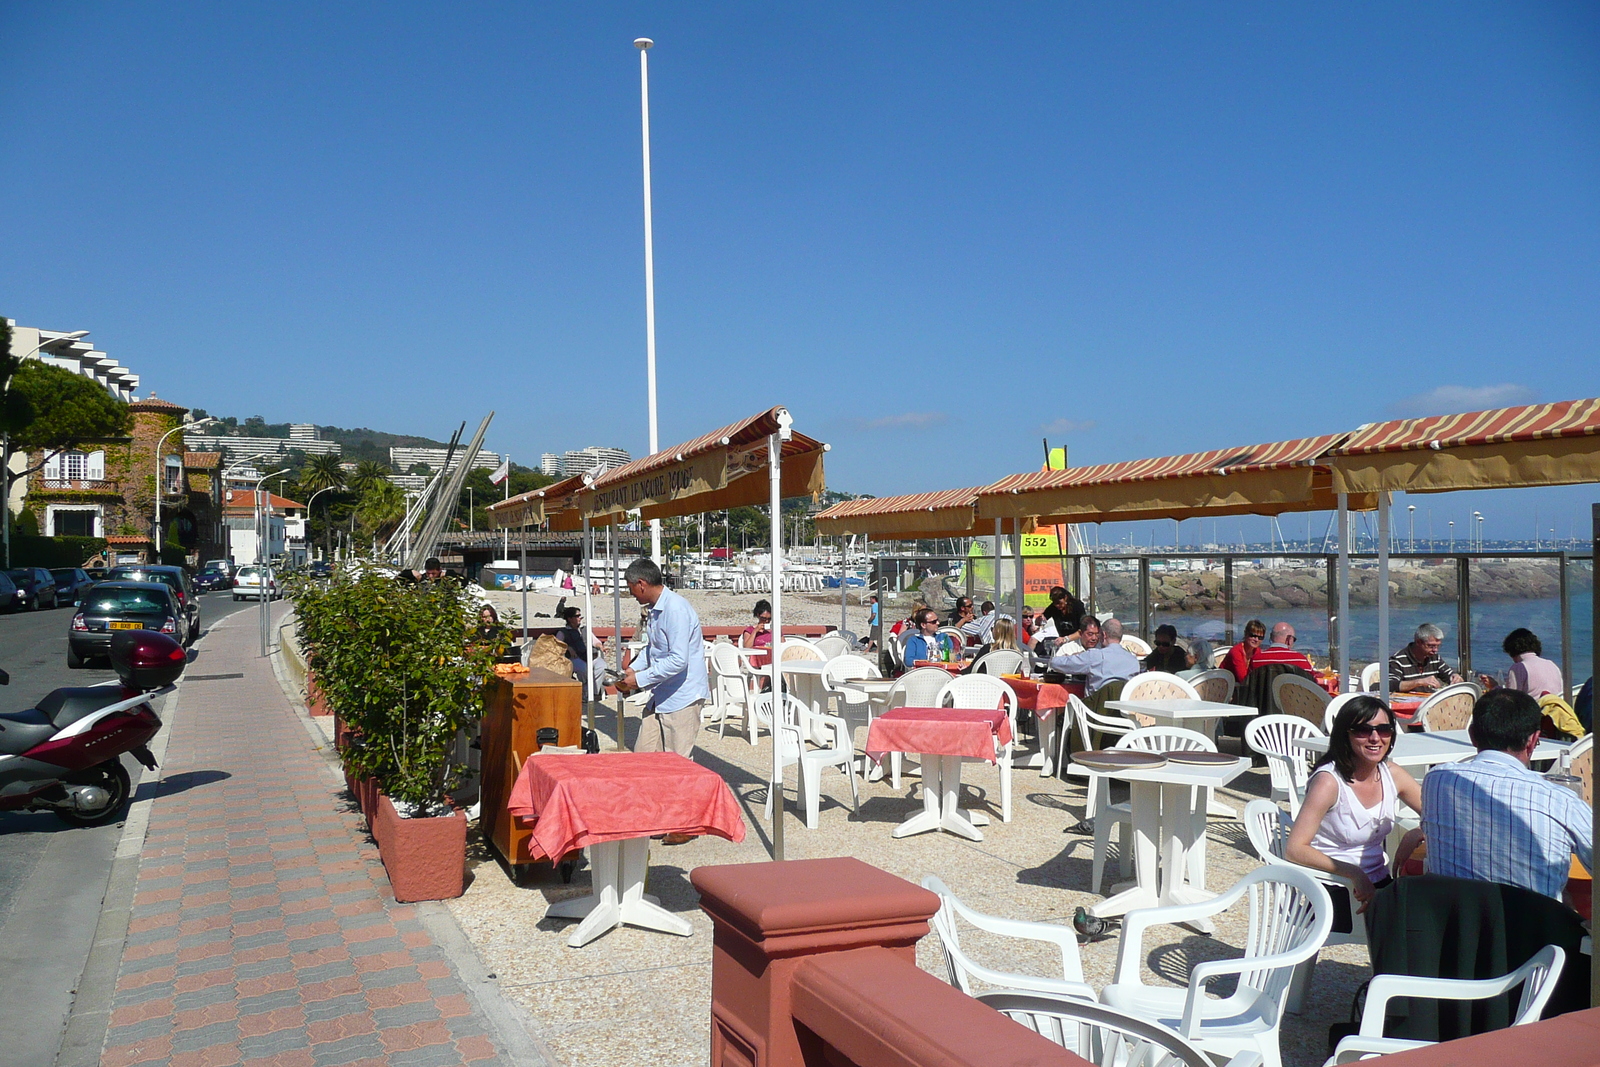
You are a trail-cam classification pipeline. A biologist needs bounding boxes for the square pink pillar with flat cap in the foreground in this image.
[690,857,939,1067]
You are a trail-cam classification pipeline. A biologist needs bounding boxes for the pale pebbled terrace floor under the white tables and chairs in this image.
[450,694,1368,1067]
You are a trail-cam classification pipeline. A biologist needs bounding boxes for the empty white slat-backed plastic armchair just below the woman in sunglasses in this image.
[1101,864,1333,1067]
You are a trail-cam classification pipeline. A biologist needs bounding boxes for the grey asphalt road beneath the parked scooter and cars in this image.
[0,592,259,1067]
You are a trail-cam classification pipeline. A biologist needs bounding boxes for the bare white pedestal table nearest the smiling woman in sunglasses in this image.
[1090,751,1256,933]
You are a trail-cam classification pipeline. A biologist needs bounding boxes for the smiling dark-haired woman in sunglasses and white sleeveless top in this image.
[1283,696,1422,933]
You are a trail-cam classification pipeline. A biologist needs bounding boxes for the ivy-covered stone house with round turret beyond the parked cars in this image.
[27,394,227,565]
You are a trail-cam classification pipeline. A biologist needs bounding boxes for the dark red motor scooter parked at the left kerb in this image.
[0,630,189,825]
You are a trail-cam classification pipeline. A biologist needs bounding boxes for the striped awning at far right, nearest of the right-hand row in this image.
[1325,400,1600,493]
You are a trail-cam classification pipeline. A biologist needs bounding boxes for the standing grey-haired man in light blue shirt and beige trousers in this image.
[618,560,710,757]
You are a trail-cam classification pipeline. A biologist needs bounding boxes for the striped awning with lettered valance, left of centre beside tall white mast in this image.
[546,408,827,530]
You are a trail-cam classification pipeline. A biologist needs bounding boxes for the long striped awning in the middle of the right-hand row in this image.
[978,434,1374,526]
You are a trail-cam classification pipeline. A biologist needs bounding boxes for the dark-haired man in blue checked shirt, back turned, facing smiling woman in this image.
[1427,689,1594,899]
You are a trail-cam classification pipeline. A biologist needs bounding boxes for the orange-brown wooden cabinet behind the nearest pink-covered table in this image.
[478,670,584,867]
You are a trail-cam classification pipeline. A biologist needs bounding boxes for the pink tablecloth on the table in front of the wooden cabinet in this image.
[506,752,744,859]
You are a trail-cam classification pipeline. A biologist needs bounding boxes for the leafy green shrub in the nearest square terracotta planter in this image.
[293,568,498,901]
